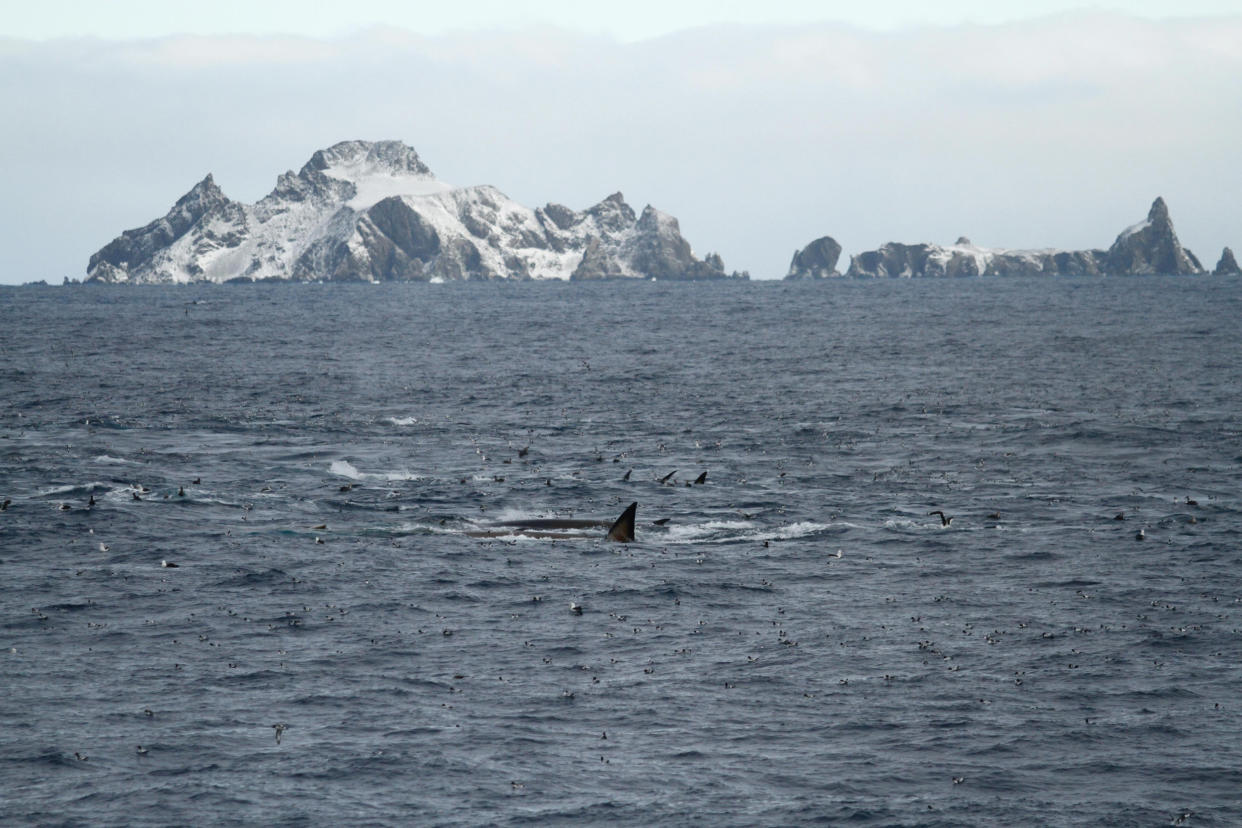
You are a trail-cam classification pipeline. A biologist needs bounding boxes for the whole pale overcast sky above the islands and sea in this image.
[0,0,1242,283]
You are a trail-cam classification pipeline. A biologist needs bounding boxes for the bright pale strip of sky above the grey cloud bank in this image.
[7,0,1242,40]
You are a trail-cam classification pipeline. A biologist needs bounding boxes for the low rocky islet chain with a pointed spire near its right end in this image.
[785,197,1236,279]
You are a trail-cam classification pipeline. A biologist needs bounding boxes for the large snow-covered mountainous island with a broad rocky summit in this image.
[86,140,748,284]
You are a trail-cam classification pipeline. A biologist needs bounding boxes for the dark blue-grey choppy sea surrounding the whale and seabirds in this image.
[0,277,1242,826]
